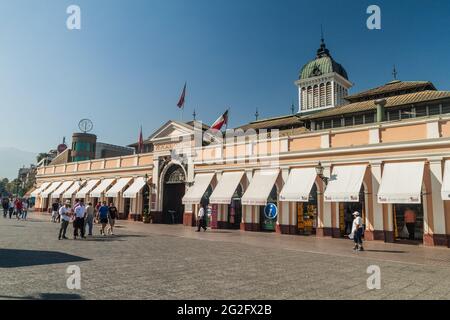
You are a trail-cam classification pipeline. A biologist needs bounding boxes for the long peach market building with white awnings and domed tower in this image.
[32,41,450,246]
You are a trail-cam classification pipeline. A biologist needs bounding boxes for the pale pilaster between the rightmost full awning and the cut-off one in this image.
[428,158,445,234]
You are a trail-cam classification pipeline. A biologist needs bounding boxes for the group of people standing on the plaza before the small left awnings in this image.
[56,200,118,240]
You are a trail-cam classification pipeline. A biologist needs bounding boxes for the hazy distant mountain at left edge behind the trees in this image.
[0,147,37,179]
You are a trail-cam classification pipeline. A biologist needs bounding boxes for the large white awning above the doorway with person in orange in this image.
[378,162,425,203]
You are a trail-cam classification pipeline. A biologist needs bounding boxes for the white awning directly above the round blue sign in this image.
[241,169,280,206]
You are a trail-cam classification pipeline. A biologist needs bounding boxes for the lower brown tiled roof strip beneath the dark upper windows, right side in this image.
[301,90,450,120]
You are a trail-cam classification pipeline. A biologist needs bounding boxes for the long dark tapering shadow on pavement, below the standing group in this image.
[0,249,89,268]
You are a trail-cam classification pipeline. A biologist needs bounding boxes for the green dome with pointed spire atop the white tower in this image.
[300,41,348,80]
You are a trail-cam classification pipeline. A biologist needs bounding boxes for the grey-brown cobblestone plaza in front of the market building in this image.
[0,210,450,299]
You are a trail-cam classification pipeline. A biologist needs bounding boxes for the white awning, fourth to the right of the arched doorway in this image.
[280,168,317,202]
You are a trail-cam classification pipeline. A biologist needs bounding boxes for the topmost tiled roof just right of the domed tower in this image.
[345,81,436,102]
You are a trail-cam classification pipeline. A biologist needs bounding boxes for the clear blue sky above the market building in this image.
[0,0,450,152]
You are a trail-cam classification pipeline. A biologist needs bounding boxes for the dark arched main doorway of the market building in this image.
[163,165,186,224]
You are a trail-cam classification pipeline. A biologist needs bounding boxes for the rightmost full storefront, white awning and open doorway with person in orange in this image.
[378,162,425,242]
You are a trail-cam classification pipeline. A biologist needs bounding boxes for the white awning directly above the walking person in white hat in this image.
[324,164,367,202]
